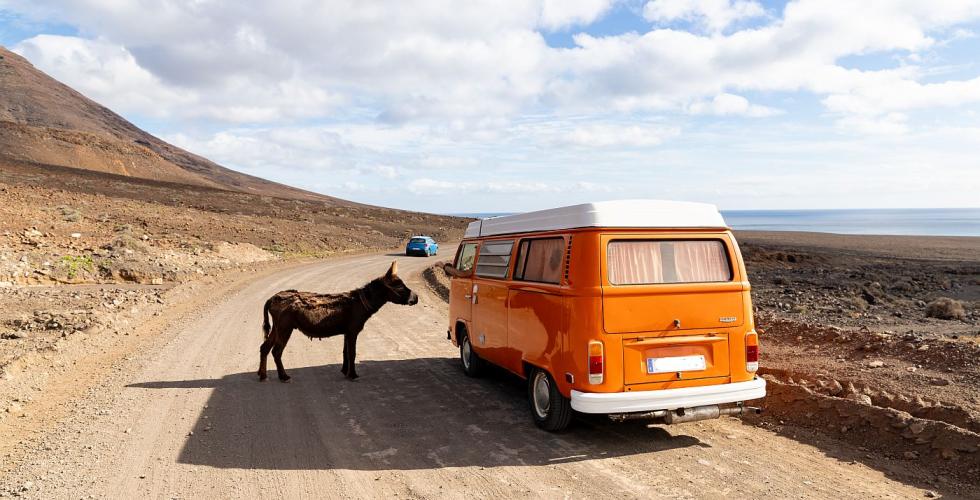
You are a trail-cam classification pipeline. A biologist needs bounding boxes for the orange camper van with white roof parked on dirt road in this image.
[449,200,766,431]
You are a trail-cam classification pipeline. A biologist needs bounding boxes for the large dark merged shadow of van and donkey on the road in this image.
[129,358,707,470]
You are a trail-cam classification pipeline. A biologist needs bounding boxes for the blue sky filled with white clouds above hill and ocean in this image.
[0,0,980,213]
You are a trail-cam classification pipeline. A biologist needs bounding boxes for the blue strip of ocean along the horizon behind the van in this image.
[452,208,980,236]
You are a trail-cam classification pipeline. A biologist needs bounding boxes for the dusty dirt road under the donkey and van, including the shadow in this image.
[0,255,936,498]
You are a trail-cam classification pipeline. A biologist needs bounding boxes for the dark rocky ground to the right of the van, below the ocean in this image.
[738,233,980,497]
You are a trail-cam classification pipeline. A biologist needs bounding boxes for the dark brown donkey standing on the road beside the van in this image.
[259,262,419,382]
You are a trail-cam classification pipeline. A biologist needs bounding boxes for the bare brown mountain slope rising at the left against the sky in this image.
[0,47,336,205]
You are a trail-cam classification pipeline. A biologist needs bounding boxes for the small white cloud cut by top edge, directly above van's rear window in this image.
[643,0,766,32]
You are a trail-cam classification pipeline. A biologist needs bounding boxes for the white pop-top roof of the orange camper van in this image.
[465,200,728,238]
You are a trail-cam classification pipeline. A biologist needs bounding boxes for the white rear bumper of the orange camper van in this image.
[572,377,766,414]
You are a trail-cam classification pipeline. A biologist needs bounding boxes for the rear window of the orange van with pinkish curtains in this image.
[606,240,732,285]
